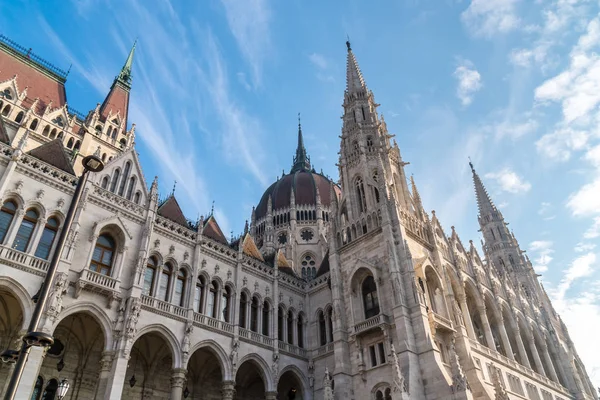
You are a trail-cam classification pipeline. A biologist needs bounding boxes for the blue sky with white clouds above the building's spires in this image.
[0,0,600,386]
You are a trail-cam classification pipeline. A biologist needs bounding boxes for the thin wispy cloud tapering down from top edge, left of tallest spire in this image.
[221,0,272,87]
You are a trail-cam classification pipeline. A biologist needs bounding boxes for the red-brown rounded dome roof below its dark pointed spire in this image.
[256,170,341,221]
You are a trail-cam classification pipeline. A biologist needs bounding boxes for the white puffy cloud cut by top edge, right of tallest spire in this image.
[461,0,519,38]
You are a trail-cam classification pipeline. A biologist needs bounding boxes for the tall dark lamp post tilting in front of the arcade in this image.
[4,154,104,400]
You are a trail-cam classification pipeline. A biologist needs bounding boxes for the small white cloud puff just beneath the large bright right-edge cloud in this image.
[535,127,589,162]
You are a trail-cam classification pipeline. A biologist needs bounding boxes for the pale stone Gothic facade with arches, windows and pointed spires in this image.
[0,36,598,400]
